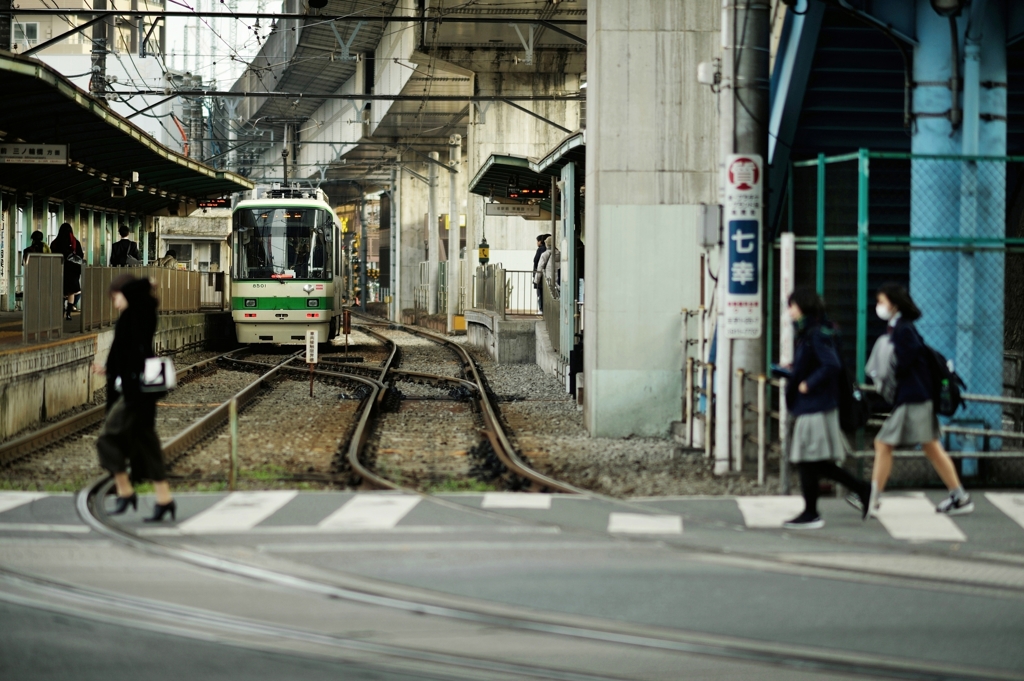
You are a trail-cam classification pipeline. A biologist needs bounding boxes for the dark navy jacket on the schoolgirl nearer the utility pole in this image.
[785,324,843,416]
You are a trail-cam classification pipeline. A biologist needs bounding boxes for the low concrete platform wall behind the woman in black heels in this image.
[0,312,233,439]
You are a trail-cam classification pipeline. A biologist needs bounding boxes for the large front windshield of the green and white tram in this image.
[233,208,334,281]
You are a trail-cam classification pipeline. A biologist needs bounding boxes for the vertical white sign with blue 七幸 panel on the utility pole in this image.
[723,154,764,339]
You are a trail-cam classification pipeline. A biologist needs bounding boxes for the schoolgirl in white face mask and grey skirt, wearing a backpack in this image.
[870,284,974,515]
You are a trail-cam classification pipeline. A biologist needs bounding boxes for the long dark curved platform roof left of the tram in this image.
[0,51,253,214]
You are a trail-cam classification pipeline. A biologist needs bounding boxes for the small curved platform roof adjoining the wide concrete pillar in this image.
[469,130,587,214]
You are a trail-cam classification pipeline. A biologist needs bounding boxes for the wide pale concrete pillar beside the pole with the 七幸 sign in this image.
[584,0,721,436]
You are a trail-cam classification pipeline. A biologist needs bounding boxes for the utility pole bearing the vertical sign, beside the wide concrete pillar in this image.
[715,0,771,473]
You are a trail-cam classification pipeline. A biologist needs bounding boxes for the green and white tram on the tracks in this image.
[231,186,343,345]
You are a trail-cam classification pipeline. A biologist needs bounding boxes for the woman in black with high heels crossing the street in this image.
[93,274,177,522]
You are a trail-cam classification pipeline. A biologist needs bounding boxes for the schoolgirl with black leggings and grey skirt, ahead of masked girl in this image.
[784,289,871,529]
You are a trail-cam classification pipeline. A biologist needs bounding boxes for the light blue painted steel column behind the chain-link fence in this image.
[910,0,1007,451]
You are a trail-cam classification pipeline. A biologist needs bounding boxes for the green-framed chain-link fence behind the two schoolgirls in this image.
[768,150,1024,483]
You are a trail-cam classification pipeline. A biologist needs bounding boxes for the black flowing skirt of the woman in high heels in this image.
[96,395,167,482]
